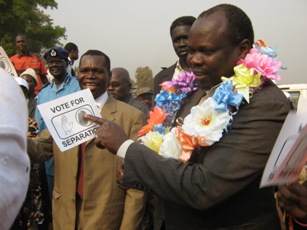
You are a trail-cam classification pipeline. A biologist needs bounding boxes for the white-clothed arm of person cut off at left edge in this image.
[0,68,30,229]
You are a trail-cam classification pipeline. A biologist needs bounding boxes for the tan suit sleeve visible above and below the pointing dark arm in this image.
[120,111,146,230]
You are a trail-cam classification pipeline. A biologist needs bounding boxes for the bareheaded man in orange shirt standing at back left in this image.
[10,34,48,93]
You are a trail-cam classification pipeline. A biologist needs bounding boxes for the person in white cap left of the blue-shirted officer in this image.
[20,68,37,118]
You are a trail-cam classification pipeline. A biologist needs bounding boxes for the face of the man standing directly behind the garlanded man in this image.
[171,25,191,59]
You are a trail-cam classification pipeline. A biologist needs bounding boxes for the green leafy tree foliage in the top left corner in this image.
[0,0,66,56]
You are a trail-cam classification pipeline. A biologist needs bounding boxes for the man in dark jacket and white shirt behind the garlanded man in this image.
[154,16,195,96]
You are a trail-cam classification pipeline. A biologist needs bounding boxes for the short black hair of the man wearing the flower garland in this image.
[199,4,254,47]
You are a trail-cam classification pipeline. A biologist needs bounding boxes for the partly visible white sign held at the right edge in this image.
[260,112,307,187]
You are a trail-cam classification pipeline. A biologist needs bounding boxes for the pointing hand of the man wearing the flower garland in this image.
[84,114,129,154]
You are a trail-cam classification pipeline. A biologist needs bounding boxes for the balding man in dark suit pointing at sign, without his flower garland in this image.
[85,4,289,230]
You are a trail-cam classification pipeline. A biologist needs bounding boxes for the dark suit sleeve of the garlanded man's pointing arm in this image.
[124,86,289,210]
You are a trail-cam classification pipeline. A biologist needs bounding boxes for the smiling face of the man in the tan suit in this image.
[78,55,111,98]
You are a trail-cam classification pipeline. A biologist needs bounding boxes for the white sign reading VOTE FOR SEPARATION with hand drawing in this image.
[37,89,101,152]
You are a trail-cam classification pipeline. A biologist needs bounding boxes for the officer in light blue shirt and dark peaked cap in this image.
[35,47,80,225]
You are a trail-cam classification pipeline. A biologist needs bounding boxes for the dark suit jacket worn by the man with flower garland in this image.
[124,82,289,230]
